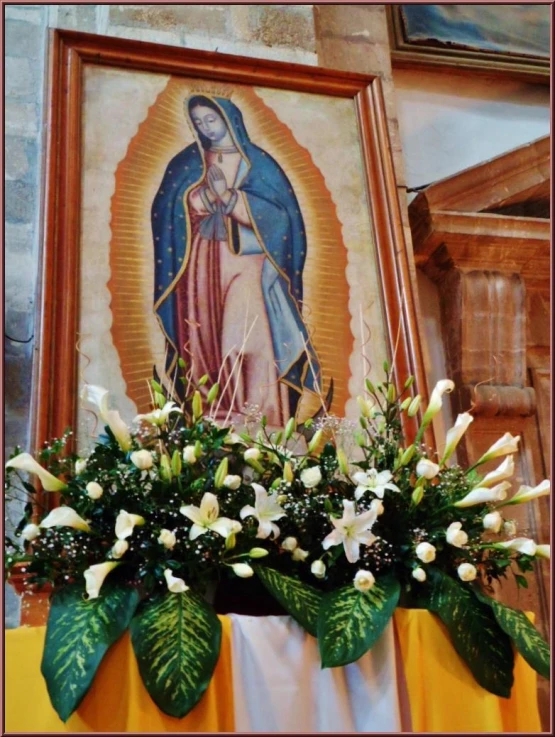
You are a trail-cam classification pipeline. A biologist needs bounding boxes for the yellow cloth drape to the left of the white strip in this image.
[5,617,235,734]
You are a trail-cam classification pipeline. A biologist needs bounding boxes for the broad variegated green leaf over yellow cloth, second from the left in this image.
[130,589,222,718]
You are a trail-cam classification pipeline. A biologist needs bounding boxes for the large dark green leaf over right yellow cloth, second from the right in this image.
[428,569,514,698]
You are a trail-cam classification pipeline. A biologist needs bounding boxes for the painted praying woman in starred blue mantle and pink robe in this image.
[152,95,321,425]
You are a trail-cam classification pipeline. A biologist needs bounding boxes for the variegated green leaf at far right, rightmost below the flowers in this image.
[476,591,550,679]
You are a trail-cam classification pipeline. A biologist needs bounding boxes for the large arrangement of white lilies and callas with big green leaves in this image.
[5,364,550,721]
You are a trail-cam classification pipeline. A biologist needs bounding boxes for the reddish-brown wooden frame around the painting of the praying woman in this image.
[34,30,426,472]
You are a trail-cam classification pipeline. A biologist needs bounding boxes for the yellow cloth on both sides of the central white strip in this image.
[5,609,541,733]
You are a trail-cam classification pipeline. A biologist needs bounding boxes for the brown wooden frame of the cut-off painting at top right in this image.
[386,5,550,84]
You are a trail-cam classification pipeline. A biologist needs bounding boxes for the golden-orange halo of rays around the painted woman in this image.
[108,77,353,420]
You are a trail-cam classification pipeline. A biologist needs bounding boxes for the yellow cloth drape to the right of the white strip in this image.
[394,609,541,733]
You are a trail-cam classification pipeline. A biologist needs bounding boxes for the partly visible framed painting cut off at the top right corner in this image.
[388,4,551,84]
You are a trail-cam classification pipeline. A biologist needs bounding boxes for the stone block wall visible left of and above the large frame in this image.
[4,5,404,626]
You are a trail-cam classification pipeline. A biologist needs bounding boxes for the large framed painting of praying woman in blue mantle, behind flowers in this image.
[36,31,425,460]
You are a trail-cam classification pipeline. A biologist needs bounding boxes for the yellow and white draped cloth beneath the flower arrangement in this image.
[5,608,541,734]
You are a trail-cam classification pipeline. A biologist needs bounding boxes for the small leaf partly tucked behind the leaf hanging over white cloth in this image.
[256,566,322,637]
